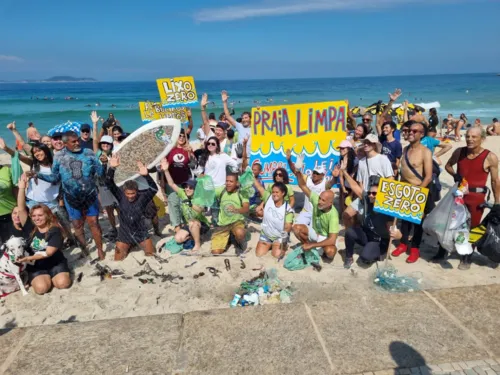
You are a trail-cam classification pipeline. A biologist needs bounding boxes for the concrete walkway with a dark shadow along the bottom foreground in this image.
[0,285,500,375]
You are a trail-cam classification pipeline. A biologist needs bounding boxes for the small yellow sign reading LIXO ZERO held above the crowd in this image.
[156,77,198,108]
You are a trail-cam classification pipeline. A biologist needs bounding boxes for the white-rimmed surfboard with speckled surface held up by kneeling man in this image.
[113,118,181,186]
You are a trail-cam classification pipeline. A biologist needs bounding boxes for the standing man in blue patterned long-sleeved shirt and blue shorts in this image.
[30,132,108,259]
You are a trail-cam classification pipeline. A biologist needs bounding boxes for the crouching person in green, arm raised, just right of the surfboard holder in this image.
[161,159,210,252]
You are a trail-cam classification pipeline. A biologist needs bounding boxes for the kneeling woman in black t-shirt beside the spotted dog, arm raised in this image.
[13,175,71,294]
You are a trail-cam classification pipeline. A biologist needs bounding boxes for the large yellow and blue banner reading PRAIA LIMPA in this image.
[251,101,348,184]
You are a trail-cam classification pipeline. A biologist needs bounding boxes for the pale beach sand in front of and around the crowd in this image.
[0,137,500,327]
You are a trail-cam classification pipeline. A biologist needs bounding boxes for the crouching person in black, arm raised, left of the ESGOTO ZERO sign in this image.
[340,164,393,268]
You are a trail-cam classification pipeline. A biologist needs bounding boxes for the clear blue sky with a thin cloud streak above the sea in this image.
[0,0,500,81]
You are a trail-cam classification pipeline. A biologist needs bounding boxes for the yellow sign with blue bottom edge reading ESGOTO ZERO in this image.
[373,178,429,224]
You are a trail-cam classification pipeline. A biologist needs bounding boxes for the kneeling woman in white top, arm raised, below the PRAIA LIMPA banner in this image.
[254,179,293,258]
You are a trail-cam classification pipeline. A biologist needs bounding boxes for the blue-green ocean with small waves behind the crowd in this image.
[0,73,500,143]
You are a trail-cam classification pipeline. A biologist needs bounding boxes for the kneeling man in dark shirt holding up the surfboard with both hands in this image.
[106,155,158,261]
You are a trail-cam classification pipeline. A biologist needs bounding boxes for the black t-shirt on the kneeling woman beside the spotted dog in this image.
[29,227,66,270]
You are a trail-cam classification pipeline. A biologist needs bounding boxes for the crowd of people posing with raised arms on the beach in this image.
[0,90,500,294]
